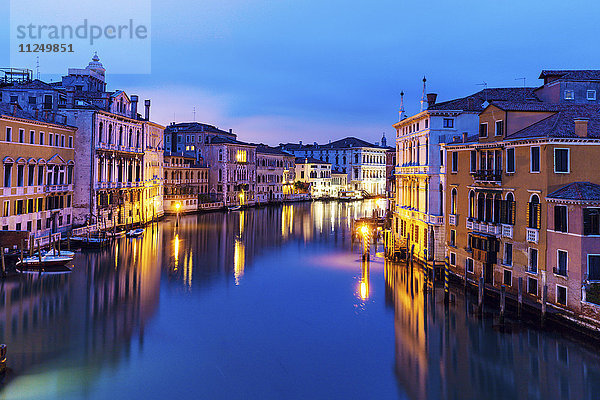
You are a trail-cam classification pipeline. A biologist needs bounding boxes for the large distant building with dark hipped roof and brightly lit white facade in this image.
[280,137,386,195]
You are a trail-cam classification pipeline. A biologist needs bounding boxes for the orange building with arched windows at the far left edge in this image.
[0,103,78,236]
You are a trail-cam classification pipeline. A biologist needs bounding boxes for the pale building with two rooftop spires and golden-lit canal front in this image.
[393,79,533,262]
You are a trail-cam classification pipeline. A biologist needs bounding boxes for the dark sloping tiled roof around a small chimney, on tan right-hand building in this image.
[506,105,600,140]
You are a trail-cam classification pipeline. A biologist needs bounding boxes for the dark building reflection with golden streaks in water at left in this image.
[0,225,161,397]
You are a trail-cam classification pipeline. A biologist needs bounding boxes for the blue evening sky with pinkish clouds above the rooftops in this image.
[0,0,600,144]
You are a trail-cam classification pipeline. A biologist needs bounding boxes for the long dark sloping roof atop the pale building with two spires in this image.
[427,87,540,111]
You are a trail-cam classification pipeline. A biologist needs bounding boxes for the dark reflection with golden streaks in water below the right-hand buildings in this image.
[385,263,600,399]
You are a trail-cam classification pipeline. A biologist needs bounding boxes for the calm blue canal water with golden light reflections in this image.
[0,201,600,399]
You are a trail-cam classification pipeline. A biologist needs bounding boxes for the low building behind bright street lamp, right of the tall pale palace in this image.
[164,153,208,214]
